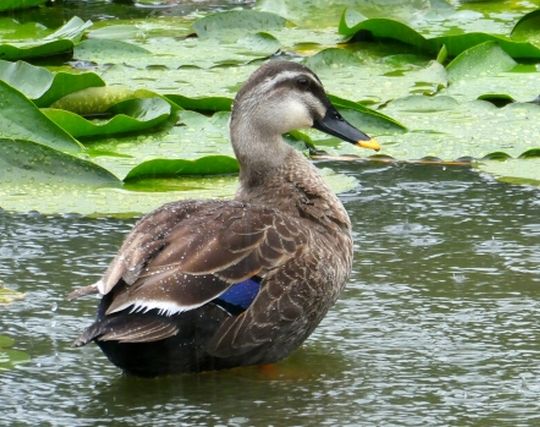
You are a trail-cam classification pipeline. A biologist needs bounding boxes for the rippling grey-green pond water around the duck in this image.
[0,163,540,426]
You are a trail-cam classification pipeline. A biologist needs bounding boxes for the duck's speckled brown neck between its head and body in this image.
[231,122,351,230]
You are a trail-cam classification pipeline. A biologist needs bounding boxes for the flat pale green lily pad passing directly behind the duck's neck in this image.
[0,169,358,217]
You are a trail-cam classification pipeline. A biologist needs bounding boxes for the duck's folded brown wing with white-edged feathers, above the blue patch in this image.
[92,201,308,315]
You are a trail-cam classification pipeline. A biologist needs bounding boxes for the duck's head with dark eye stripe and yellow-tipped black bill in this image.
[231,61,380,151]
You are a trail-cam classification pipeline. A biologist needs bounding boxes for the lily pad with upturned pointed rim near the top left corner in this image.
[0,16,92,60]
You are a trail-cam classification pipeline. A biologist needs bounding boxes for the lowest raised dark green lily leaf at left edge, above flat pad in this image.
[0,138,120,186]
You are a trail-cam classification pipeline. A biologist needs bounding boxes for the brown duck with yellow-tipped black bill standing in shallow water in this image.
[71,60,380,377]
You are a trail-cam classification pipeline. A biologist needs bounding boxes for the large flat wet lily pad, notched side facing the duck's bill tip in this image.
[379,96,540,160]
